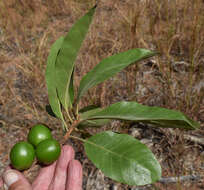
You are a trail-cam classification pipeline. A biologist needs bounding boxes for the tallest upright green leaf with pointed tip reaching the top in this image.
[56,8,95,111]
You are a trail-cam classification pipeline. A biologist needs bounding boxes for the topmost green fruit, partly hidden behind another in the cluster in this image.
[28,124,52,147]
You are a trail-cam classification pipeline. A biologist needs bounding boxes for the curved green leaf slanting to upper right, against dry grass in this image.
[77,49,156,101]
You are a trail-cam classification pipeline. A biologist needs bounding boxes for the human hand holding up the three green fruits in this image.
[0,145,82,190]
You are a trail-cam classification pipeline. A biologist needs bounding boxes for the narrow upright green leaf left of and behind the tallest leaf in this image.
[45,37,64,120]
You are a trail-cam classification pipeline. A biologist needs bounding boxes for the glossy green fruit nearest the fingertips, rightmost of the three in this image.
[36,139,61,165]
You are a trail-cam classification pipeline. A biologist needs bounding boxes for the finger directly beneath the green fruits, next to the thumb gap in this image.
[32,162,56,190]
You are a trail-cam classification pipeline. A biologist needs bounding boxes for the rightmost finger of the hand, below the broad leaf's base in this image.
[66,160,82,190]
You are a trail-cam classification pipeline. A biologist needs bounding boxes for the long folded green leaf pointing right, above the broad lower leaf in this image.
[80,101,199,129]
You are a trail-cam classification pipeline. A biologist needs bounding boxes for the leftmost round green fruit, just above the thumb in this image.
[10,141,35,170]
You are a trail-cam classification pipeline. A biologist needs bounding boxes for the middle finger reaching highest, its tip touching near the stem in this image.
[49,145,74,190]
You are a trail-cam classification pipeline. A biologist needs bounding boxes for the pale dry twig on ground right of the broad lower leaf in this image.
[159,175,202,184]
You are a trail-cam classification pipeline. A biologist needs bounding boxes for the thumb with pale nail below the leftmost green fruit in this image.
[3,169,32,190]
